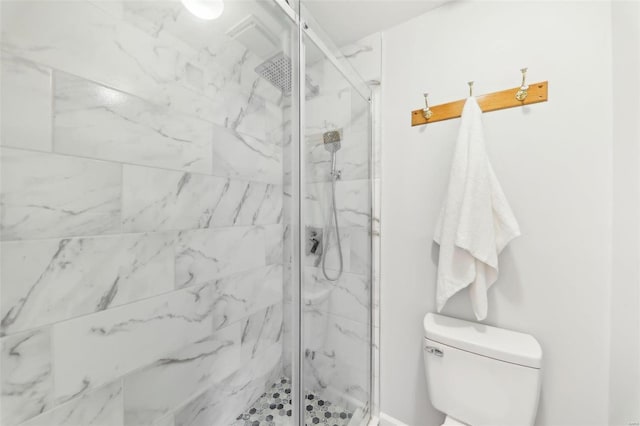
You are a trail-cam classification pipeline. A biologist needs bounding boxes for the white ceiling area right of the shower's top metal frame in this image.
[302,0,447,47]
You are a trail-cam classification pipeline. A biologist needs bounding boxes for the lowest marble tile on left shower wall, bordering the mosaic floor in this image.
[175,344,282,426]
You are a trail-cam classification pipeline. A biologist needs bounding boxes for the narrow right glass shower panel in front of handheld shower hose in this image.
[300,34,372,426]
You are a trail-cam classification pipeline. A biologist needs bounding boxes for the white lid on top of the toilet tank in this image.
[424,313,542,368]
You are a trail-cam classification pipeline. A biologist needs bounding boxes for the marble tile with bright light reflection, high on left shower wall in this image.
[53,72,213,173]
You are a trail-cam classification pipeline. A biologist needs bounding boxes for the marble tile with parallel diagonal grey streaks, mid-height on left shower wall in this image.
[122,165,282,232]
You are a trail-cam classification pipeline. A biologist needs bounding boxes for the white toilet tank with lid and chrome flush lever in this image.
[423,313,542,426]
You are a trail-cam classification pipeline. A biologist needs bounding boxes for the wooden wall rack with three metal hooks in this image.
[411,68,549,126]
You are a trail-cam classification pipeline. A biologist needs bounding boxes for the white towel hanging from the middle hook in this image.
[434,97,520,320]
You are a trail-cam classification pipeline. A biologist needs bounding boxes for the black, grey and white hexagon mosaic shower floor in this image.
[232,378,352,426]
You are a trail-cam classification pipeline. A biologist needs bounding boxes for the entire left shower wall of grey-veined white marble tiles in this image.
[0,1,283,426]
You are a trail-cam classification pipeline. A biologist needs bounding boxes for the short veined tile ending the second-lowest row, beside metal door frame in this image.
[241,303,284,363]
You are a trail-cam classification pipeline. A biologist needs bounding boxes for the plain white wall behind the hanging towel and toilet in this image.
[381,2,613,426]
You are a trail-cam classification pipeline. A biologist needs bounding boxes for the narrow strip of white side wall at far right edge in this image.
[609,1,640,425]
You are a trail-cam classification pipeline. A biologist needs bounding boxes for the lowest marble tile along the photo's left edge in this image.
[0,329,53,426]
